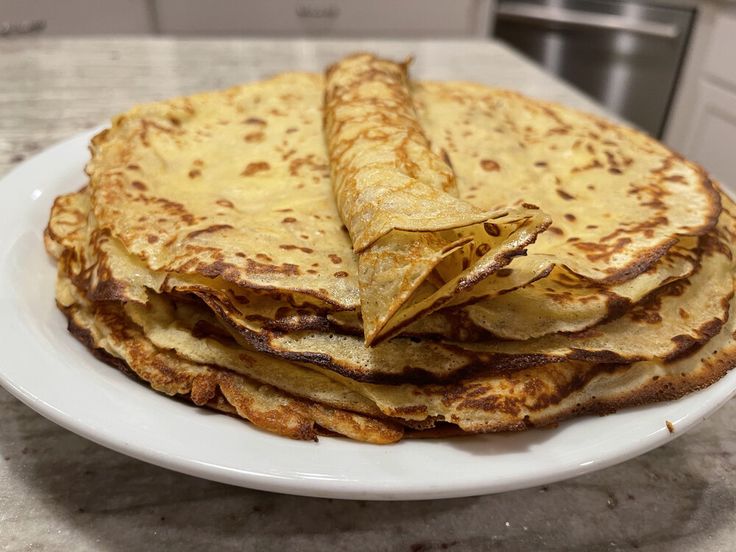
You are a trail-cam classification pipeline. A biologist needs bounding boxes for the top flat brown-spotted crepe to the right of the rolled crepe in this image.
[413,82,720,283]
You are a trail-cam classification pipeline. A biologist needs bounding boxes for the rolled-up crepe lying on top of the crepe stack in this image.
[324,54,550,345]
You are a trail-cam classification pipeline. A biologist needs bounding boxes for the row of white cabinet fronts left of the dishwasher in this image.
[0,0,494,38]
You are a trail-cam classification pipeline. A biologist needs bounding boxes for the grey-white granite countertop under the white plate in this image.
[0,38,736,552]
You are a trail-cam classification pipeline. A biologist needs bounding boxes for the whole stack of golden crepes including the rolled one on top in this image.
[46,54,736,443]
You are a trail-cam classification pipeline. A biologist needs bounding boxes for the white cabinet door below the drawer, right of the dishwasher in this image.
[684,81,736,188]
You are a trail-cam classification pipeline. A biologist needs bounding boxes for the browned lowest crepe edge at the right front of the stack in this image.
[310,286,736,433]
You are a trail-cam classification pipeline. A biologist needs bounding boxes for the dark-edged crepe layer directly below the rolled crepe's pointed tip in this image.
[213,225,733,382]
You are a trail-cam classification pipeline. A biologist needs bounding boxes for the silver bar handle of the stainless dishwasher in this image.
[496,4,680,39]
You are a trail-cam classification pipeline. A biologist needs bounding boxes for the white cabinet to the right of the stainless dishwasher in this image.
[665,2,736,192]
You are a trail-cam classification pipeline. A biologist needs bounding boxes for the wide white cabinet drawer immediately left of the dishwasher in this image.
[156,0,491,37]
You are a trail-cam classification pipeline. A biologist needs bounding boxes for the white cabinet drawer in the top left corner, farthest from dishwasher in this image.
[0,0,154,37]
